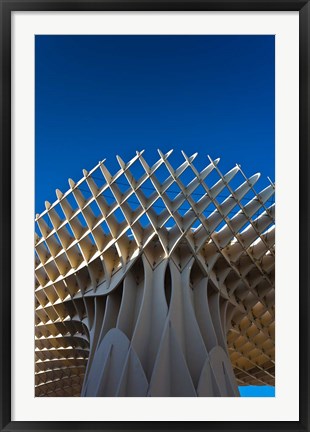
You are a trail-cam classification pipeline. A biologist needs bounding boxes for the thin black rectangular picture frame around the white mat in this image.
[0,0,310,431]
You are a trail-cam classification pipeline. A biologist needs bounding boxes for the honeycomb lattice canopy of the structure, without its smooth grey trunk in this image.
[35,151,275,396]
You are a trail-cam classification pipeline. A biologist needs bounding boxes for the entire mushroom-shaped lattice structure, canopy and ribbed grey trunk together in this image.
[35,151,275,396]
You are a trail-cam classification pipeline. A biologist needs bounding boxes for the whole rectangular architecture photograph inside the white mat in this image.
[34,34,280,398]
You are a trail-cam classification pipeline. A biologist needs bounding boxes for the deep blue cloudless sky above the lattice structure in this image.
[35,36,275,395]
